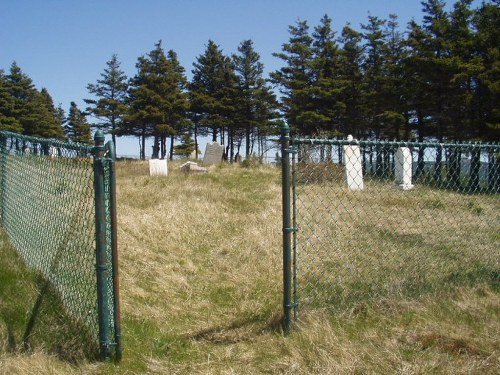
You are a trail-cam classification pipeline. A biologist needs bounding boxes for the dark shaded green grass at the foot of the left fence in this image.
[0,234,99,364]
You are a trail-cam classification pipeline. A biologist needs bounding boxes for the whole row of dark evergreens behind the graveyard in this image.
[0,0,500,160]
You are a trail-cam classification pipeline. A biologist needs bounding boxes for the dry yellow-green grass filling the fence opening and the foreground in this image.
[0,162,500,374]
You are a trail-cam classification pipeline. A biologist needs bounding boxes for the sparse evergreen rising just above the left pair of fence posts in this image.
[85,54,128,145]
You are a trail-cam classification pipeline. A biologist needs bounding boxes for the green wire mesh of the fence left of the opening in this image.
[0,132,120,360]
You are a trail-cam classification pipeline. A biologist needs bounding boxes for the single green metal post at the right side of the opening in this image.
[281,124,294,333]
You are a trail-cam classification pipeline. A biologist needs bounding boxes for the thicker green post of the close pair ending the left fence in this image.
[94,130,110,360]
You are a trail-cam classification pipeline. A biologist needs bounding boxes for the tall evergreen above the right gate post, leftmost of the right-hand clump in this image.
[270,21,318,135]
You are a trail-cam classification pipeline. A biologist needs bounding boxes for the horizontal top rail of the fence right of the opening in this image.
[291,138,500,151]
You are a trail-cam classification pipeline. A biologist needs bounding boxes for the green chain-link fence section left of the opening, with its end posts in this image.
[0,131,121,359]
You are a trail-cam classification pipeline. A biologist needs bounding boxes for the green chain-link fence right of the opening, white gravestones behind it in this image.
[282,123,500,329]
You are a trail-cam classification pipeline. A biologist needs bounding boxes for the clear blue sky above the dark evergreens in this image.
[0,0,482,156]
